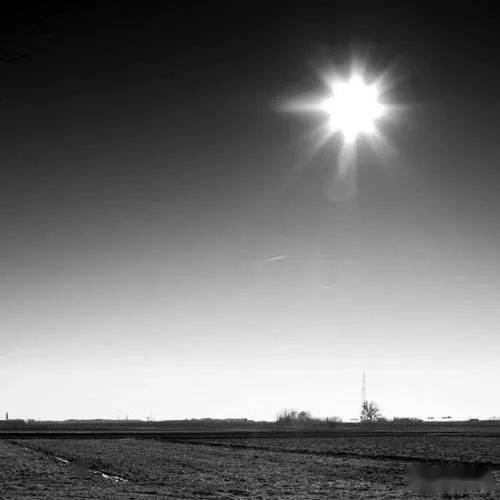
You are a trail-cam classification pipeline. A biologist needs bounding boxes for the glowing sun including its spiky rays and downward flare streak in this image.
[281,59,400,201]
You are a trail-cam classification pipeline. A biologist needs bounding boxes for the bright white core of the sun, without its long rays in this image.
[319,73,386,144]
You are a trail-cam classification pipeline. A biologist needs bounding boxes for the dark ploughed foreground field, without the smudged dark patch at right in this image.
[0,432,500,499]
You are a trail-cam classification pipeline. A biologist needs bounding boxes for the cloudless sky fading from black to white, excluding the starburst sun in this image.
[0,1,500,419]
